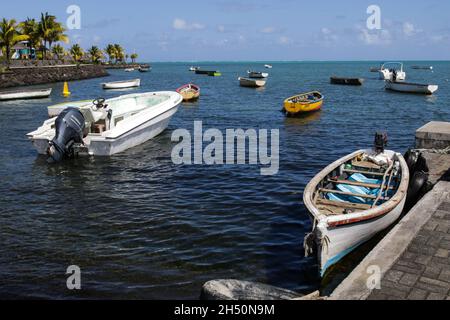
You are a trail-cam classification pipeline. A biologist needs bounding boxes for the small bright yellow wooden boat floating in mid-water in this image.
[283,91,324,116]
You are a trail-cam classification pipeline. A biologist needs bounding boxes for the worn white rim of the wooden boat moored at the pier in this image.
[303,149,409,227]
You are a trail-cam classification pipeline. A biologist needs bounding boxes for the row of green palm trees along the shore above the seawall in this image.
[0,12,138,65]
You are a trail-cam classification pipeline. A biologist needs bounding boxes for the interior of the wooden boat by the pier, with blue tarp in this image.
[313,153,401,216]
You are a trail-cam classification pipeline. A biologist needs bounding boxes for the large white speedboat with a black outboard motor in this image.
[27,91,183,162]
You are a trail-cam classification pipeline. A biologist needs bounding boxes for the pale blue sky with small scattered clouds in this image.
[0,0,450,61]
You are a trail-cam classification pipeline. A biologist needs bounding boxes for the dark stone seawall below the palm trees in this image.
[0,65,109,89]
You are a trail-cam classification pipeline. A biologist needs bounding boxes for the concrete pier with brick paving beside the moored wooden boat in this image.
[329,122,450,300]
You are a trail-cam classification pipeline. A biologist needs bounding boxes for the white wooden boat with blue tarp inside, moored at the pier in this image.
[303,141,409,276]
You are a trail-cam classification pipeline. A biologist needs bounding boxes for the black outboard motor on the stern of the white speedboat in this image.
[47,108,85,163]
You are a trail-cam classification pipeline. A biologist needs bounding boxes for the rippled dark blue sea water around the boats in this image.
[0,62,450,299]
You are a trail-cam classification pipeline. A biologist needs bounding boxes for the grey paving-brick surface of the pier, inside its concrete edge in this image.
[368,201,450,300]
